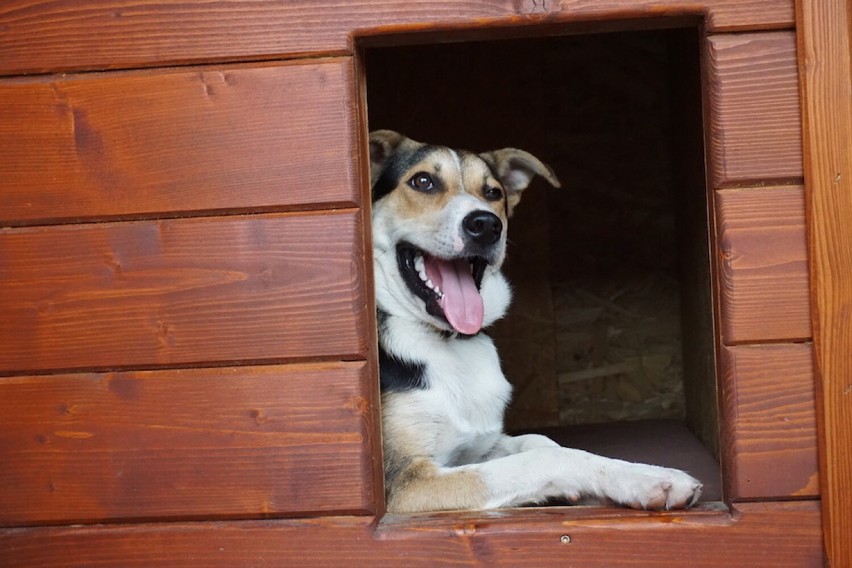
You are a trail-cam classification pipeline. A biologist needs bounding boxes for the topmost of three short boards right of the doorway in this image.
[707,31,802,187]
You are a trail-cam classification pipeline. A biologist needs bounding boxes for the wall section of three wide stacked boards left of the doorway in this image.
[0,55,381,526]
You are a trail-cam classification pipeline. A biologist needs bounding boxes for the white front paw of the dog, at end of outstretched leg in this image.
[608,463,701,509]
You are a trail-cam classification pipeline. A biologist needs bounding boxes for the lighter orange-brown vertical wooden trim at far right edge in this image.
[796,0,852,566]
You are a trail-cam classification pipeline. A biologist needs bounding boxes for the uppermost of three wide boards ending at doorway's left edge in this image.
[0,59,359,225]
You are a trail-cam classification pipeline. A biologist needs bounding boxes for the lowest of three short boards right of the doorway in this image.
[719,344,819,500]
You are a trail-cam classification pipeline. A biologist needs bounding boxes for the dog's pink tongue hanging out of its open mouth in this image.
[425,257,485,335]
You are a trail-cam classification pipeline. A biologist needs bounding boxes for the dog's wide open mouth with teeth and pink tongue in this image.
[396,242,488,335]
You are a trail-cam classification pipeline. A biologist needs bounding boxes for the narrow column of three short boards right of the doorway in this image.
[707,31,819,499]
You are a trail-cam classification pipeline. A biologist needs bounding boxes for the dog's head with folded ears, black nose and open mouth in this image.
[370,130,559,335]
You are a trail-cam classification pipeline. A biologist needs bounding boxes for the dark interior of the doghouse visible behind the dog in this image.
[364,26,722,500]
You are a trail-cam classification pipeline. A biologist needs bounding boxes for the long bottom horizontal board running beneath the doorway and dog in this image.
[0,501,823,568]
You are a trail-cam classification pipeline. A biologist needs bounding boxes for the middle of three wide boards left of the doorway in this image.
[0,210,369,374]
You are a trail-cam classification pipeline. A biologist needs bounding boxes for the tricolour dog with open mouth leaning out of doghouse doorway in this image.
[369,130,701,513]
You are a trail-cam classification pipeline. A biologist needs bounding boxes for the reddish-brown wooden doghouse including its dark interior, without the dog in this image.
[0,0,852,567]
